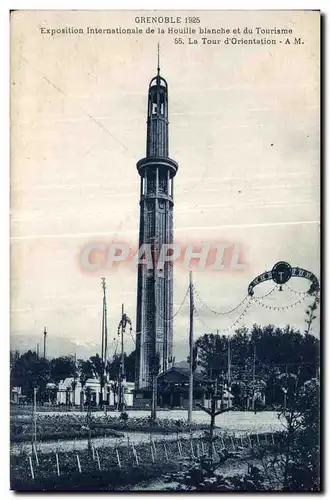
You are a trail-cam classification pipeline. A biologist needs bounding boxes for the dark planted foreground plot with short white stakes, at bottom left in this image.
[11,434,281,491]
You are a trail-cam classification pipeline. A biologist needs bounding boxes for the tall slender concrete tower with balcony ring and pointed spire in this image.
[136,56,178,389]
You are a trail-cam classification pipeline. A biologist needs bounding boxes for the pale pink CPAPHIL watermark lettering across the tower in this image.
[79,242,246,272]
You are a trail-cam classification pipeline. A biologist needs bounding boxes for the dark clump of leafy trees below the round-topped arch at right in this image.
[196,324,319,409]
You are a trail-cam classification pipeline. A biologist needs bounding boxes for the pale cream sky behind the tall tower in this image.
[11,11,320,359]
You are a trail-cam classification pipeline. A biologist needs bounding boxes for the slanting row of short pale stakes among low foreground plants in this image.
[11,435,278,479]
